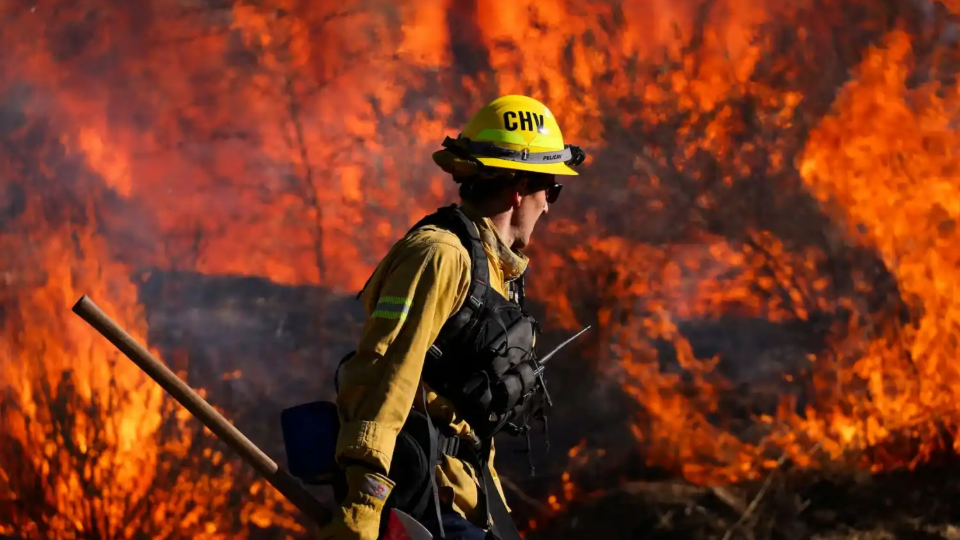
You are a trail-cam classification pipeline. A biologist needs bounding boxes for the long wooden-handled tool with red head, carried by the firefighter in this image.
[73,296,433,540]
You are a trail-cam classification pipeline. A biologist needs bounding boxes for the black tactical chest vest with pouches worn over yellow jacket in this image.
[411,205,545,440]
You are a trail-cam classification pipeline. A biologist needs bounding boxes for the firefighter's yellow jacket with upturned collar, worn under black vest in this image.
[337,206,528,527]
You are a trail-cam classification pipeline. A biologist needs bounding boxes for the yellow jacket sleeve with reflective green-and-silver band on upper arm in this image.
[337,242,470,474]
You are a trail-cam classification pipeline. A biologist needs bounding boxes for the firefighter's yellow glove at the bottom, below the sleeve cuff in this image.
[319,465,396,540]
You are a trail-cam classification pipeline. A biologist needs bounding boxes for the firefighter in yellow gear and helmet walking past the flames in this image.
[321,95,584,540]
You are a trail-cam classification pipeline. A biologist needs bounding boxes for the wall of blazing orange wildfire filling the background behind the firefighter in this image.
[0,0,960,538]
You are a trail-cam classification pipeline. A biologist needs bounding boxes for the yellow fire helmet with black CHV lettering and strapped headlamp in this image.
[433,95,586,180]
